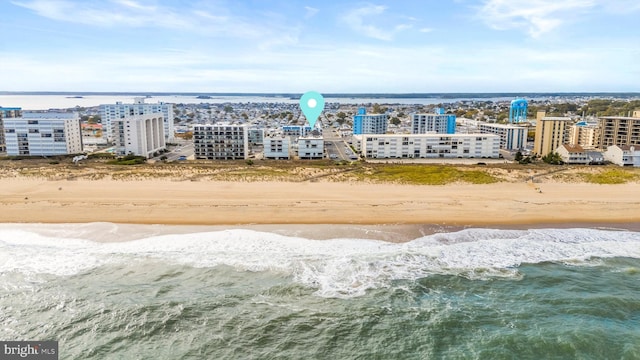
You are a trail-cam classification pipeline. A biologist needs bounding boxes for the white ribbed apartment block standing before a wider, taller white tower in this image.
[112,113,166,159]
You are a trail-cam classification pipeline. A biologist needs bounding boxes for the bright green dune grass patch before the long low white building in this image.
[366,165,500,185]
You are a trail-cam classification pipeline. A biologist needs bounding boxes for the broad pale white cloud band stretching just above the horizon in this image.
[0,40,640,92]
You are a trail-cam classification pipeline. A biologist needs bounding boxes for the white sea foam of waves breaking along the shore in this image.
[0,224,640,297]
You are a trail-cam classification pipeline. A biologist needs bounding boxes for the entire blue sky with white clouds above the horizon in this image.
[0,0,640,93]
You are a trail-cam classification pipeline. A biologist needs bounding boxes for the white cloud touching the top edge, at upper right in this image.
[479,0,596,38]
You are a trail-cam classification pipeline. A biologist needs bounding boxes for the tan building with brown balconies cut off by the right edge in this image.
[600,116,640,149]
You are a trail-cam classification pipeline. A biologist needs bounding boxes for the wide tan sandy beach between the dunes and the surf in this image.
[0,177,640,226]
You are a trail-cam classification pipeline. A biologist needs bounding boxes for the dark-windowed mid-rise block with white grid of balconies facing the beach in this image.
[193,124,249,160]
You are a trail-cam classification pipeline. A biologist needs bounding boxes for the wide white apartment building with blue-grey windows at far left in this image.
[4,111,82,156]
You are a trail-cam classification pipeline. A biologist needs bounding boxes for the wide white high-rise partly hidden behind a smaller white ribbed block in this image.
[100,97,174,142]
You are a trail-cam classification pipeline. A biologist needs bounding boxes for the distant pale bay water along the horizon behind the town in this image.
[0,92,640,110]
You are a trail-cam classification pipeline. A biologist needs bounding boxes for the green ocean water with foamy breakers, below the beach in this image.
[0,224,640,359]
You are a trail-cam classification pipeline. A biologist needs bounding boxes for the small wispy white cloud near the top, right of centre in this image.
[342,4,412,41]
